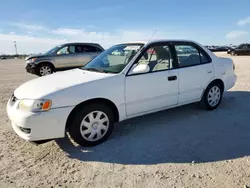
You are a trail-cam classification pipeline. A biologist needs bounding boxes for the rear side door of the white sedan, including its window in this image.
[173,42,214,104]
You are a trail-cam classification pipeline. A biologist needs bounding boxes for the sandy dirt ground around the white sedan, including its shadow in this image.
[0,53,250,188]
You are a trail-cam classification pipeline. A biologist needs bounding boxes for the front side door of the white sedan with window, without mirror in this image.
[125,43,179,117]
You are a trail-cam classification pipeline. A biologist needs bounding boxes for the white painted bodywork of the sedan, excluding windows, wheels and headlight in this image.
[7,40,236,141]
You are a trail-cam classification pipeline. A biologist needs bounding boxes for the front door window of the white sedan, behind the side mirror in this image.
[135,45,173,72]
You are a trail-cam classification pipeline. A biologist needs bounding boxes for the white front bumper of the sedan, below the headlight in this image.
[7,97,73,141]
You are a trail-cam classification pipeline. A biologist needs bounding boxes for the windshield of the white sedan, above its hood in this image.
[82,44,143,73]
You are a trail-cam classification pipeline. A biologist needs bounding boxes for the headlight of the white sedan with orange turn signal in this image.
[18,99,52,112]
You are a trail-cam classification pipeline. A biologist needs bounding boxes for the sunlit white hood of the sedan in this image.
[14,69,114,99]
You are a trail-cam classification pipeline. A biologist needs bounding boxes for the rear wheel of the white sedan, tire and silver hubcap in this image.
[200,82,223,110]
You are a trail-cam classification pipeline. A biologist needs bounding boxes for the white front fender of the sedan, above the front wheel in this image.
[46,75,126,120]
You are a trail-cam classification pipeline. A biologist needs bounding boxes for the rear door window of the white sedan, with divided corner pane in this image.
[174,45,210,67]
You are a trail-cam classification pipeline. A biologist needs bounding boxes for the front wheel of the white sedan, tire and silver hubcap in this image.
[69,104,114,147]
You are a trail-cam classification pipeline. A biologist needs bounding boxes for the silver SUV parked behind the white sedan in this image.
[25,43,104,76]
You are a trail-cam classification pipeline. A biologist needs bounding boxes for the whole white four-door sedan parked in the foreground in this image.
[7,40,236,146]
